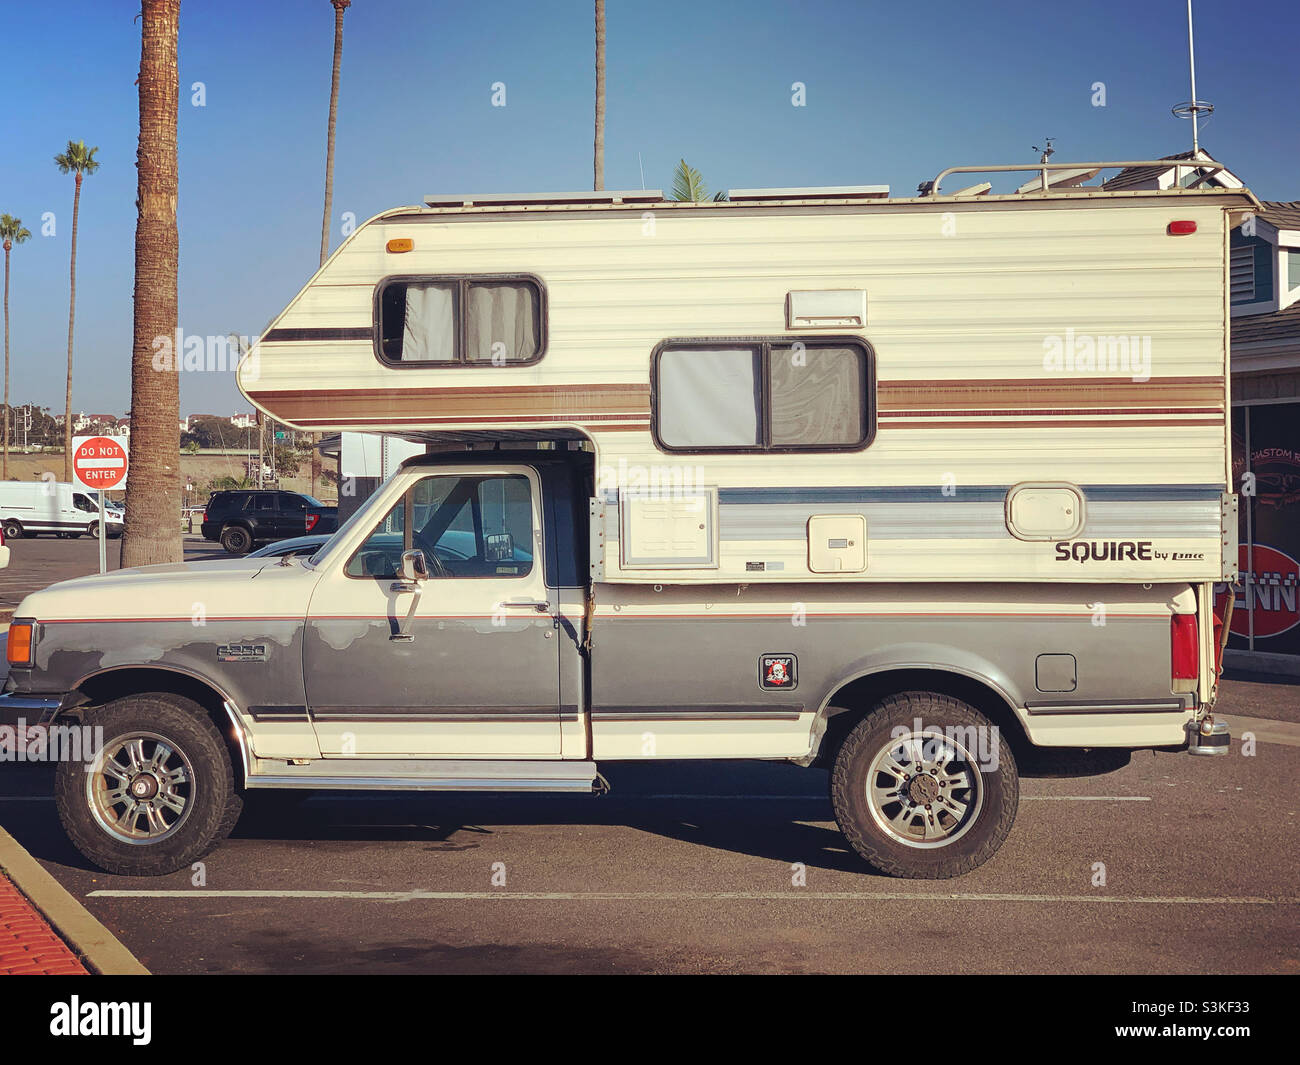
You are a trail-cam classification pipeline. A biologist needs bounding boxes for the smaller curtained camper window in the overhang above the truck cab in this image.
[374,276,546,367]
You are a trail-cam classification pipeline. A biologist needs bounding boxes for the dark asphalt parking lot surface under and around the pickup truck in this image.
[0,540,1300,974]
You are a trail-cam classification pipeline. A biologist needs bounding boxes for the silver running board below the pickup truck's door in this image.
[244,758,607,795]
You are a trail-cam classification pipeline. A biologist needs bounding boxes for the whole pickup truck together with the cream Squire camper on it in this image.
[0,157,1258,878]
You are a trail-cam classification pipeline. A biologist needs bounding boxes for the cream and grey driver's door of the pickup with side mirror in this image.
[303,466,560,758]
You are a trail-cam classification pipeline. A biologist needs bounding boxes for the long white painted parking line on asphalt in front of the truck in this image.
[86,888,1300,906]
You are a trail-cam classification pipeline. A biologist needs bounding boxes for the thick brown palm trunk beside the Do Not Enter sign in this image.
[122,0,182,567]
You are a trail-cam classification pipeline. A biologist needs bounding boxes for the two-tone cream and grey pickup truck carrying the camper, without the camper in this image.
[0,449,1229,878]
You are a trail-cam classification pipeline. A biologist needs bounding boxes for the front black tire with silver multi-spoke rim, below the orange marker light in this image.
[55,693,242,876]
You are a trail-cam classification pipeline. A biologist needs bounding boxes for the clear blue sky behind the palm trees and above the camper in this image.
[0,0,1300,412]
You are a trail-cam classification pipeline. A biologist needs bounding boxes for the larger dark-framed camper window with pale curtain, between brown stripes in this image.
[651,338,875,451]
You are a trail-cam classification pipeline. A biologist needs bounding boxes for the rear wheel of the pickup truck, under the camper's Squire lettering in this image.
[831,692,1021,880]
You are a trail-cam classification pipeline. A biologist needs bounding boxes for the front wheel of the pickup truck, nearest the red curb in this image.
[55,693,241,876]
